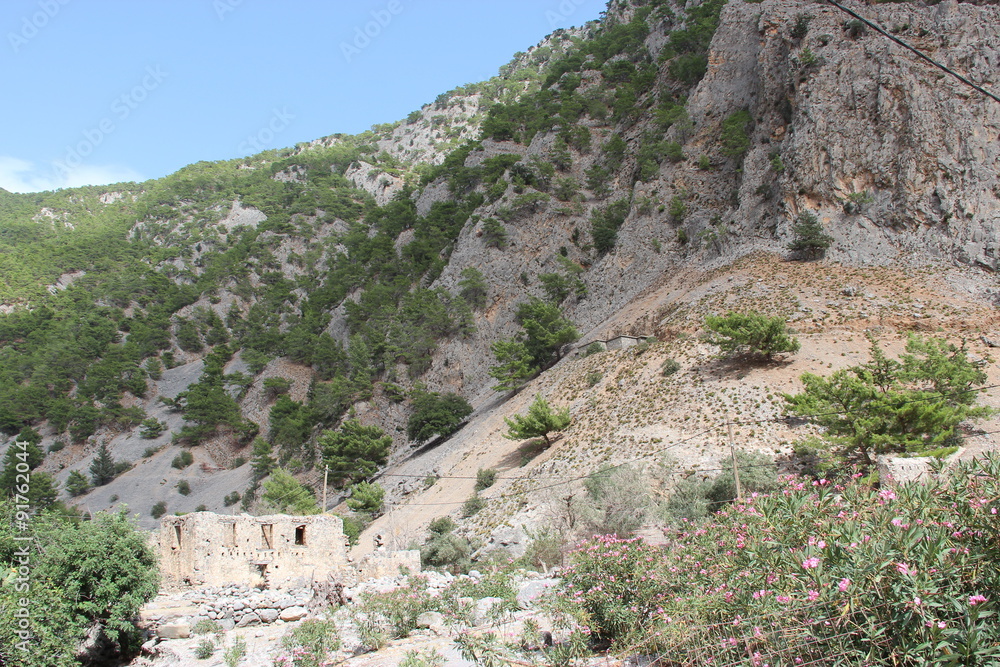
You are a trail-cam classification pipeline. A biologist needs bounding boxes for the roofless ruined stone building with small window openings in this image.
[159,512,353,588]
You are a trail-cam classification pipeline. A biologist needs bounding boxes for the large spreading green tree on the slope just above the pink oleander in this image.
[785,336,991,465]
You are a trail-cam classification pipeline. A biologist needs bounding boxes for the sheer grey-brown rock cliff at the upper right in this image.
[688,0,1000,269]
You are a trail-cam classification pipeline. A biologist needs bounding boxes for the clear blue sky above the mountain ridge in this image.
[0,0,605,192]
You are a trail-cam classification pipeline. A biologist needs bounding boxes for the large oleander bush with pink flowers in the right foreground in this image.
[563,455,1000,665]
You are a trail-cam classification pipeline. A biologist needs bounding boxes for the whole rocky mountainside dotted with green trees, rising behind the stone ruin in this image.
[0,0,1000,544]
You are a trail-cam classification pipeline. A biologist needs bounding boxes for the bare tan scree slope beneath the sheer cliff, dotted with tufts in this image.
[353,253,1000,557]
